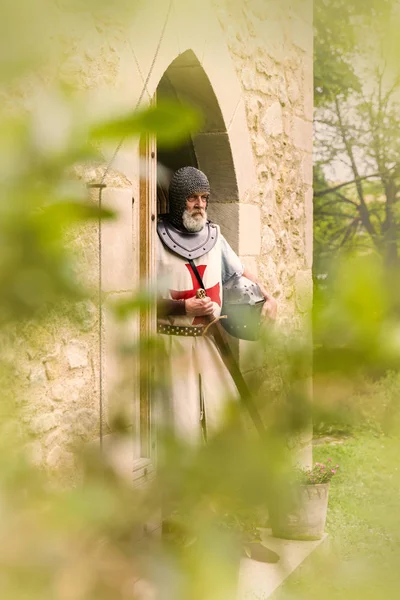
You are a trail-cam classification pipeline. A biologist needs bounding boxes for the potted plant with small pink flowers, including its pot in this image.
[271,458,339,540]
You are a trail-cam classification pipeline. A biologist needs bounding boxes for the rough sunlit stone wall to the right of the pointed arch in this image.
[214,0,313,329]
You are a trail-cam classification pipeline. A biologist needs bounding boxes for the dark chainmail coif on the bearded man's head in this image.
[168,167,210,229]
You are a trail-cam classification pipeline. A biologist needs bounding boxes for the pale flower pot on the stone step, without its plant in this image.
[271,483,329,540]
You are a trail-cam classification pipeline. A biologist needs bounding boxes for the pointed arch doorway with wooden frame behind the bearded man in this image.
[137,50,244,480]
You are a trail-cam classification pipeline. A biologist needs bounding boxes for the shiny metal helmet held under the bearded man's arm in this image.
[221,275,265,341]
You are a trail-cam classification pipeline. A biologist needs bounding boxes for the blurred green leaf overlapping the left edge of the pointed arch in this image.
[91,101,202,147]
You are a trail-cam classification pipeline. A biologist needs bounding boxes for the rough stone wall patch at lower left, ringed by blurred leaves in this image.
[16,301,99,478]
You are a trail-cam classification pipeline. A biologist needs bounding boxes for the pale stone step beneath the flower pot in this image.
[238,529,328,600]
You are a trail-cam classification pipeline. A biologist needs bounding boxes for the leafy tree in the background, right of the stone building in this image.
[314,0,400,269]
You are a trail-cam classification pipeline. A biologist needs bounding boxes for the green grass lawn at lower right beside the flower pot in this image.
[276,434,400,600]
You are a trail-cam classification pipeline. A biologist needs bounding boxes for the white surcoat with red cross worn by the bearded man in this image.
[157,227,237,442]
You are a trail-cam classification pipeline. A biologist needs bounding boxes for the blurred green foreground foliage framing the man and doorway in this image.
[0,0,399,600]
